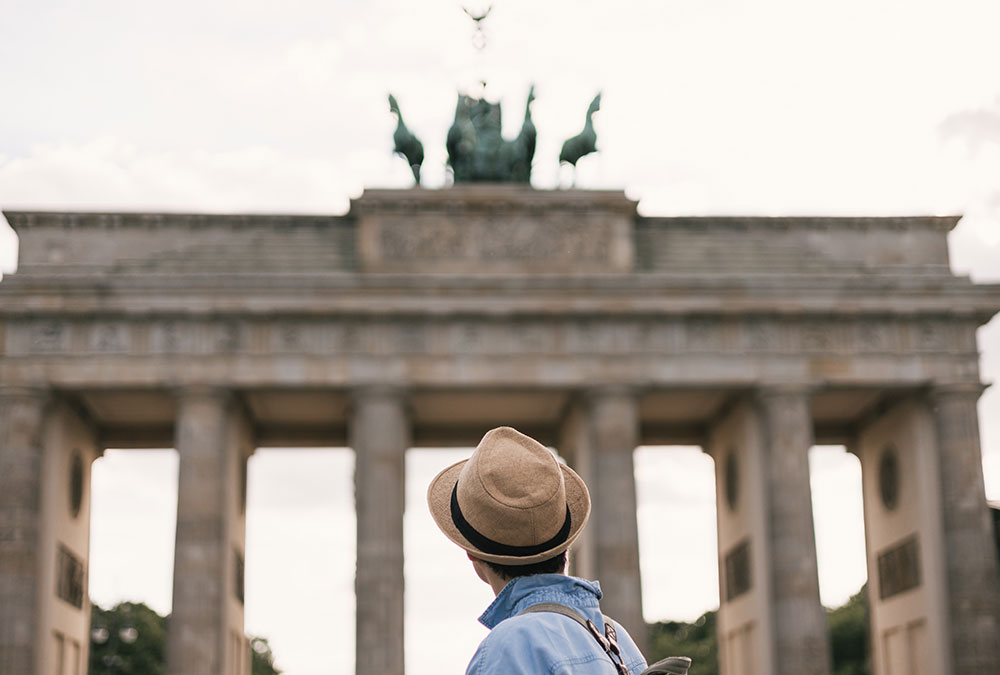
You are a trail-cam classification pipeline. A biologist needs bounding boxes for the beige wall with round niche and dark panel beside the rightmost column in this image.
[852,393,955,673]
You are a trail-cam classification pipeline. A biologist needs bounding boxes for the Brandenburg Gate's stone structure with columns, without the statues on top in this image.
[0,184,1000,675]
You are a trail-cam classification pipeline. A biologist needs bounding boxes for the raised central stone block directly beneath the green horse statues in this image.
[352,185,635,274]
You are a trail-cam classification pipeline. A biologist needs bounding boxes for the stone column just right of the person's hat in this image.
[589,389,649,653]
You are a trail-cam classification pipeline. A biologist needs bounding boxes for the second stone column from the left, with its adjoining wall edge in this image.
[167,388,250,675]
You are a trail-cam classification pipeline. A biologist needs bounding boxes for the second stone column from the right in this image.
[757,389,831,675]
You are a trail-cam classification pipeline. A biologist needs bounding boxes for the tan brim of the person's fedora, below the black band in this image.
[427,459,590,565]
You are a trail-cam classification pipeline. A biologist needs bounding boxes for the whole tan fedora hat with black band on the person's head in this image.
[427,427,590,565]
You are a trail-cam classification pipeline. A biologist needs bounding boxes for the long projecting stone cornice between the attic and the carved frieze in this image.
[0,275,1000,323]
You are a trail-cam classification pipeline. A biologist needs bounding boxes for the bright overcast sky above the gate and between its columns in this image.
[0,0,1000,675]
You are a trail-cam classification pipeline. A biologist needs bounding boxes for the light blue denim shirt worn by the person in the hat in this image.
[465,574,646,675]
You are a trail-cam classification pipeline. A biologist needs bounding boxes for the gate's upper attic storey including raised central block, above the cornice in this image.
[5,185,958,277]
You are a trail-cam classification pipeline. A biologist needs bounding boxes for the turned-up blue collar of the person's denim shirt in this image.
[479,574,602,630]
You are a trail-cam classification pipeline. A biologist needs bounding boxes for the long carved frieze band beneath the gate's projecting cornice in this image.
[3,316,976,358]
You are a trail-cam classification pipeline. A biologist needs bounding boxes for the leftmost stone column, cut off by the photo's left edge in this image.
[0,387,48,674]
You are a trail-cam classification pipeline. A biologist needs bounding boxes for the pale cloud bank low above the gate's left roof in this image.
[0,137,391,213]
